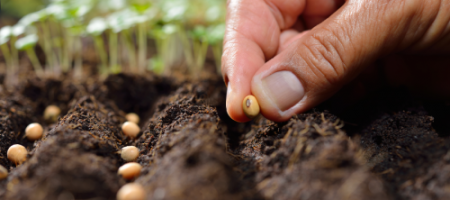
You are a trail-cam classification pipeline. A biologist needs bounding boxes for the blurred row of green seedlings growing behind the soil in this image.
[0,0,226,80]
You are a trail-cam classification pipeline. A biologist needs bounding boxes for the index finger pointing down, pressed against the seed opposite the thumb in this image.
[222,0,305,122]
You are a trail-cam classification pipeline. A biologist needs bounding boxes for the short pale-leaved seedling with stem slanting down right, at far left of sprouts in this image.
[15,34,44,77]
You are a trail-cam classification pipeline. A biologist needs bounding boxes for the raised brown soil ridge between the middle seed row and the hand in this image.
[136,81,254,199]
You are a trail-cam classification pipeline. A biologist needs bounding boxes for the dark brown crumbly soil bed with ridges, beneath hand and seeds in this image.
[0,71,450,200]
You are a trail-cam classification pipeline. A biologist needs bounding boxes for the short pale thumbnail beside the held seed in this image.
[262,71,305,111]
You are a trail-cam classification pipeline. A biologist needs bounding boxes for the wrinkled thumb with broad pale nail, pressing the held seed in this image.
[251,0,445,121]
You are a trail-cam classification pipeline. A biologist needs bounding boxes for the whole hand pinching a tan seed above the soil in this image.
[222,0,450,122]
